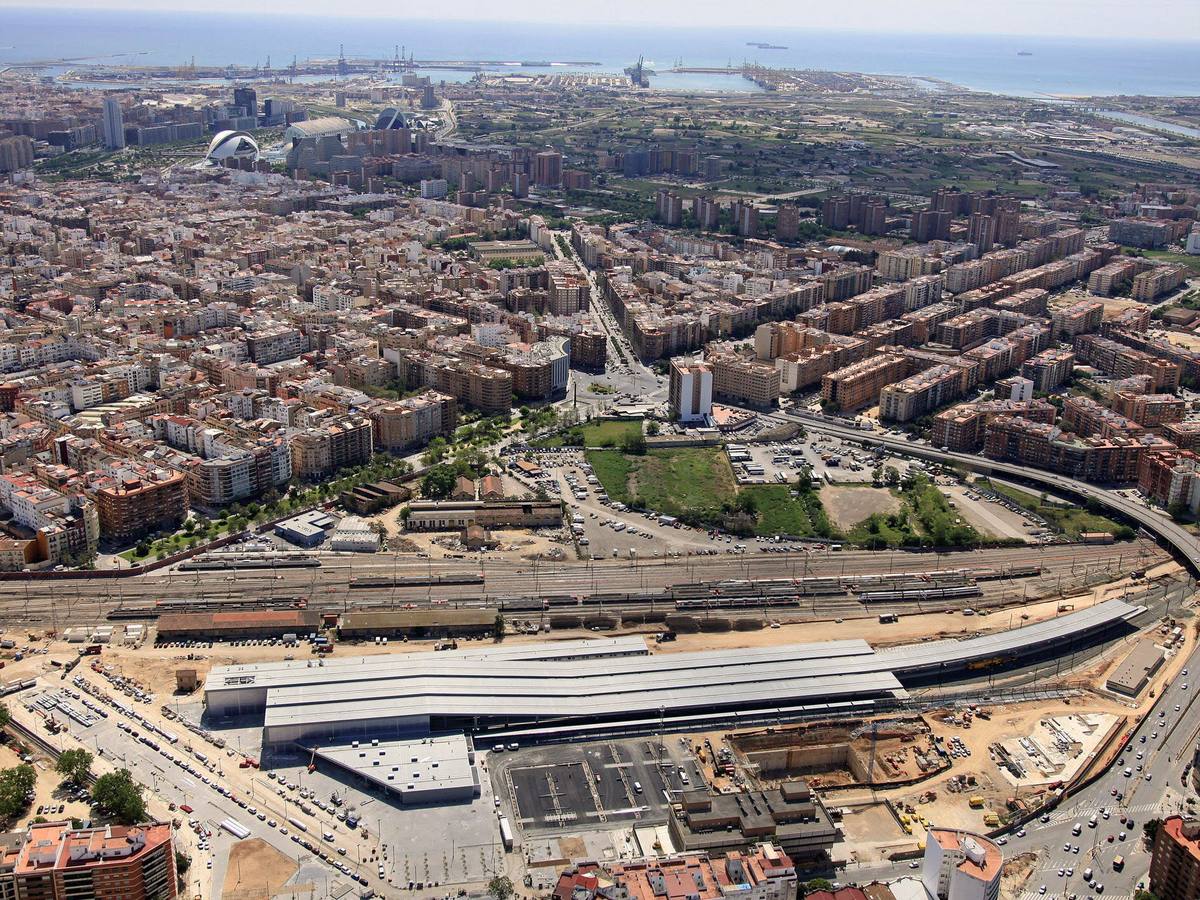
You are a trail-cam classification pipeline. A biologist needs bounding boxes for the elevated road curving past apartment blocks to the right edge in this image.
[780,413,1200,575]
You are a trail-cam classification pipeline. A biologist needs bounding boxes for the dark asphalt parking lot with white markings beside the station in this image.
[490,737,704,833]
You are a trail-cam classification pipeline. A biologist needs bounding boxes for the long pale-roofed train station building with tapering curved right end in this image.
[204,600,1145,745]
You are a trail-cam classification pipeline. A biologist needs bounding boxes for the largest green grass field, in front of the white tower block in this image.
[588,446,737,521]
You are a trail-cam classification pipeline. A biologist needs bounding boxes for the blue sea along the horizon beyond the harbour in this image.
[0,7,1200,97]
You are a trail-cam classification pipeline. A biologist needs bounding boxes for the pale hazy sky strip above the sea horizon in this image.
[7,0,1200,41]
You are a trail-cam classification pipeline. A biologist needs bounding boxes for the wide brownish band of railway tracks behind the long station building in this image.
[0,541,1168,629]
